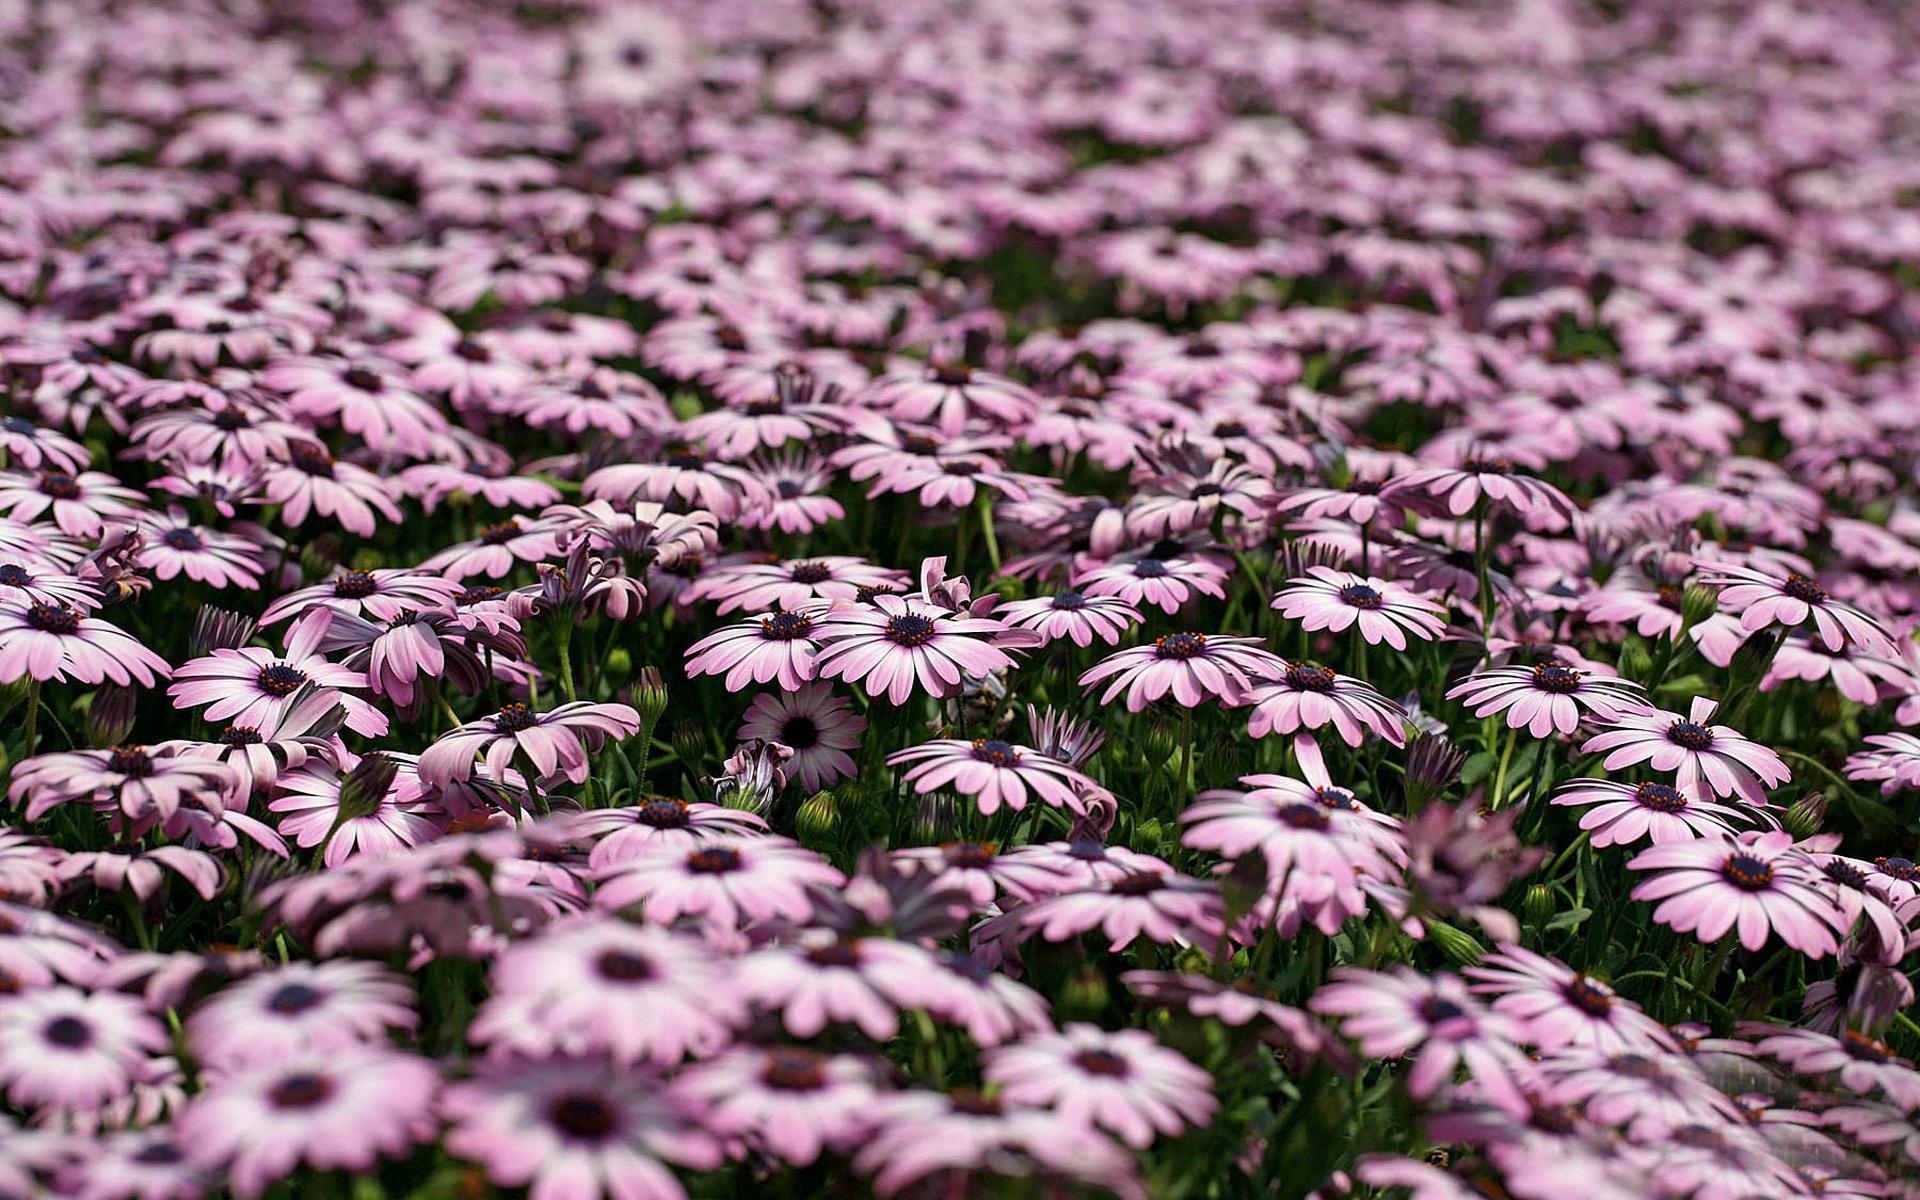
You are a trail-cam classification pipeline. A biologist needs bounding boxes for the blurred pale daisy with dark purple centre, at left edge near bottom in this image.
[0,987,169,1112]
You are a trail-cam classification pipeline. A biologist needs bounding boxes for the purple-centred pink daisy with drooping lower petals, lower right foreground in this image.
[1308,966,1528,1117]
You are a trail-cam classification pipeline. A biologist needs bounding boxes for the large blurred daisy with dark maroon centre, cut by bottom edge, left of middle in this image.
[442,1058,724,1200]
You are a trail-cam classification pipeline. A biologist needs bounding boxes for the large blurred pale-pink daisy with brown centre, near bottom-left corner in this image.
[175,1046,440,1198]
